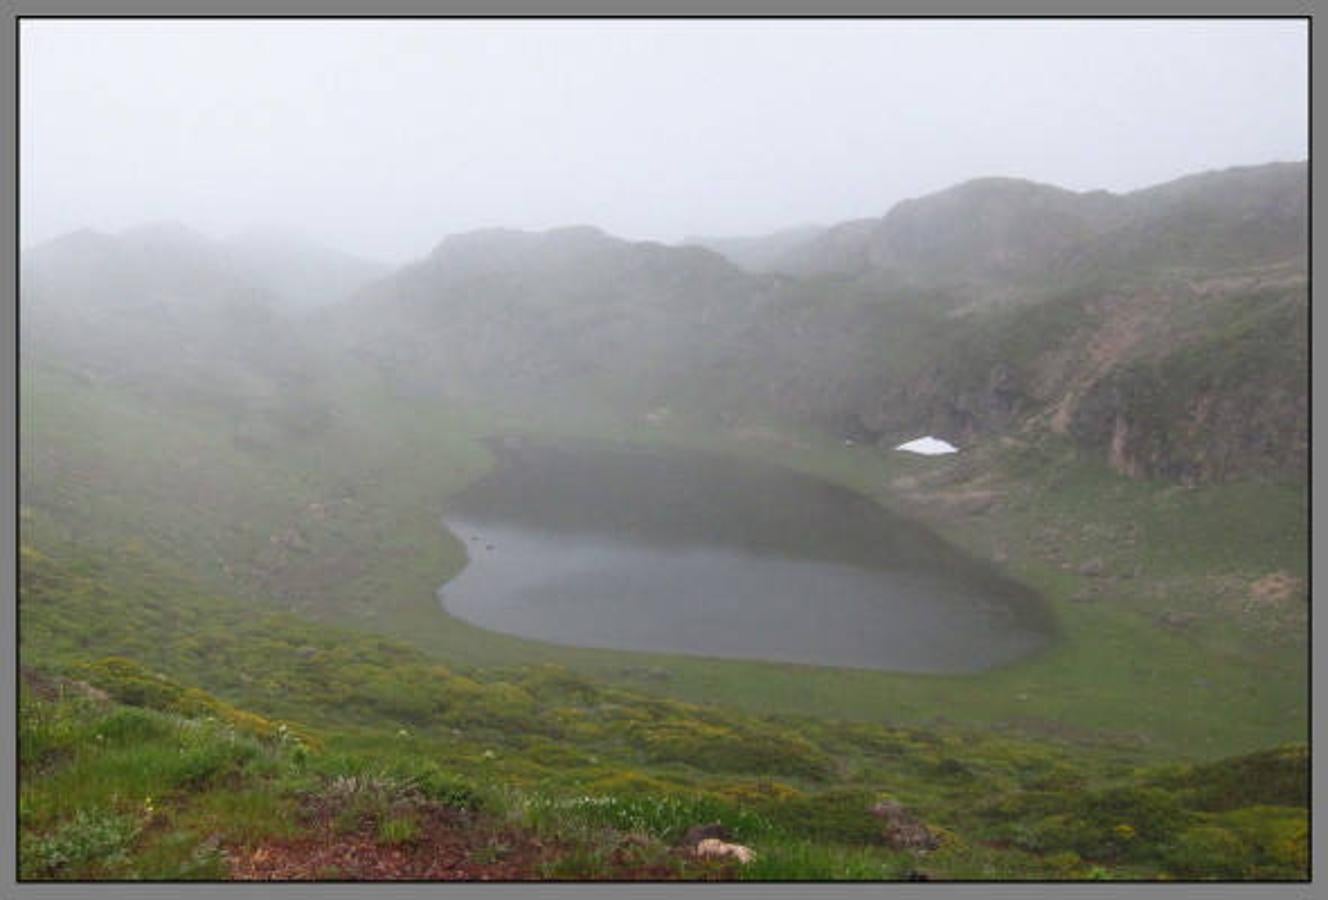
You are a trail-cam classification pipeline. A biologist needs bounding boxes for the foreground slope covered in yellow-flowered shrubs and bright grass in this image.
[19,547,1307,879]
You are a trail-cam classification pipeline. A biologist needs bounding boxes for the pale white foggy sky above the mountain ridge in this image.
[20,19,1308,262]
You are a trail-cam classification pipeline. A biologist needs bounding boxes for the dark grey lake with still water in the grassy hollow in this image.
[438,439,1053,672]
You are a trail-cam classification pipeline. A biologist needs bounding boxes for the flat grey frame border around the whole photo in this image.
[0,0,1328,900]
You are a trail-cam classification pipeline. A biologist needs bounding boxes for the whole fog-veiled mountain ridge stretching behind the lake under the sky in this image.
[24,162,1308,481]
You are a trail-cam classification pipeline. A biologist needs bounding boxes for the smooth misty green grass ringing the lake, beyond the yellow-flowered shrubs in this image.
[23,358,1307,755]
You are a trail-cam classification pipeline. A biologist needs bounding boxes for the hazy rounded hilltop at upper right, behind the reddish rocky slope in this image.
[772,163,1305,283]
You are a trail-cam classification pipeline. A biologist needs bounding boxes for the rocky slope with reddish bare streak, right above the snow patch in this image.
[857,263,1309,483]
